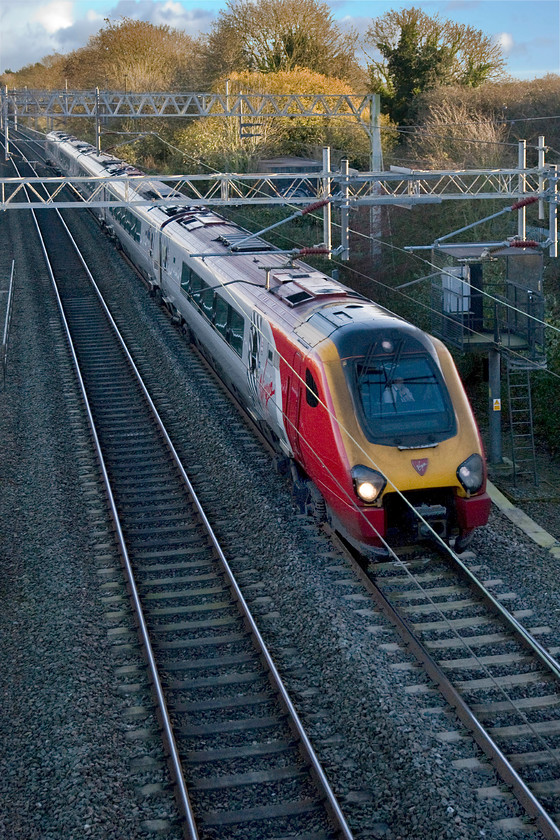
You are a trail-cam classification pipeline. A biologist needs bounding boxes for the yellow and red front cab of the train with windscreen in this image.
[300,319,490,546]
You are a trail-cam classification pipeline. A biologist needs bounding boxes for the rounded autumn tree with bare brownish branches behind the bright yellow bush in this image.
[201,0,363,88]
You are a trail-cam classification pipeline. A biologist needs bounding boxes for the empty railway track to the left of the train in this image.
[6,136,351,840]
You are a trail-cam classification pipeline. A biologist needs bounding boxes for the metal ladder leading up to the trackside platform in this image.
[506,360,539,486]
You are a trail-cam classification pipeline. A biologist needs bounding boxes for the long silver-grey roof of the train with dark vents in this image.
[49,132,414,347]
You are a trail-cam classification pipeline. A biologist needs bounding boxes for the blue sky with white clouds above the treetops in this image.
[0,0,560,79]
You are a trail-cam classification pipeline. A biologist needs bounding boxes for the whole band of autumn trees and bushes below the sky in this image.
[0,6,560,171]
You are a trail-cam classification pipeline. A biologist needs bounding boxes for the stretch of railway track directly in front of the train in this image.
[340,536,560,838]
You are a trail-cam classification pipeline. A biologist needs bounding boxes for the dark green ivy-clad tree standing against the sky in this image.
[366,8,505,125]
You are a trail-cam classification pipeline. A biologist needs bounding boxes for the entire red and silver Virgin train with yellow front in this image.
[47,132,490,551]
